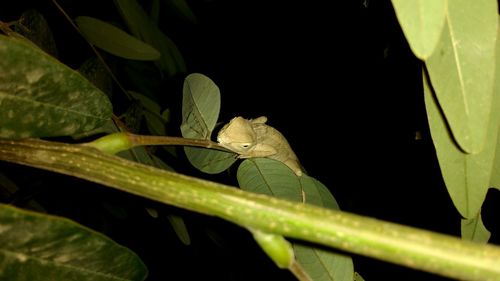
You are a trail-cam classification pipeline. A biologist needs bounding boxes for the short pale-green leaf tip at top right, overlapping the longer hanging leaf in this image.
[392,0,446,60]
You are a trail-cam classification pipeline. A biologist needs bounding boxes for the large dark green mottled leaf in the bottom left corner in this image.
[0,205,147,281]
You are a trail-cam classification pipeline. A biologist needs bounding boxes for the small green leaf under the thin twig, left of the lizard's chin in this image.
[184,146,238,174]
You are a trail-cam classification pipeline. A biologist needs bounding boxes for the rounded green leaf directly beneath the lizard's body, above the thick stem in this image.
[237,158,302,202]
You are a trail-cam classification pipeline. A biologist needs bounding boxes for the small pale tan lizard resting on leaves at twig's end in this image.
[217,116,303,176]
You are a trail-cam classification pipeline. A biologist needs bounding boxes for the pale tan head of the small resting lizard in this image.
[217,117,257,153]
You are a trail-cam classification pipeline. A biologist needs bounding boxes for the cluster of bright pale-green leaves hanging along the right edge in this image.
[392,0,500,242]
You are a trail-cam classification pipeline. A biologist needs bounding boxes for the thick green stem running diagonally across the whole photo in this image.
[0,140,500,280]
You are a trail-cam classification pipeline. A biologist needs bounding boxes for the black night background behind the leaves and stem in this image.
[0,0,500,280]
